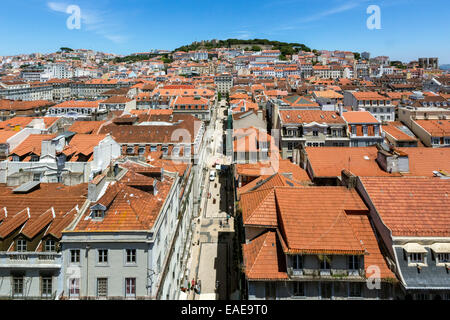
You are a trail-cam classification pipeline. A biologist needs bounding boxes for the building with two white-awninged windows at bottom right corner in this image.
[357,177,450,300]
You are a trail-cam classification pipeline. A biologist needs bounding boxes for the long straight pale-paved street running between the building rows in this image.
[188,100,237,300]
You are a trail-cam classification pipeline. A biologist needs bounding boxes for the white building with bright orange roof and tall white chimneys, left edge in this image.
[0,130,121,186]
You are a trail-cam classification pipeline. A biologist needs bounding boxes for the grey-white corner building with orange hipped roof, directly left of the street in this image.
[61,161,190,299]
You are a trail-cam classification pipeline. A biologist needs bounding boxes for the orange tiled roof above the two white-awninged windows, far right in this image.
[360,177,450,237]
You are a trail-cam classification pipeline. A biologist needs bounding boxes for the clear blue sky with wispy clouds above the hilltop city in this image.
[0,0,450,64]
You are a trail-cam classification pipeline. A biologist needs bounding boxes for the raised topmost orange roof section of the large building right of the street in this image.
[275,187,367,254]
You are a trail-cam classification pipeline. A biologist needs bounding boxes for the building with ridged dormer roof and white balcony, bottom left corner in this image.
[0,182,87,300]
